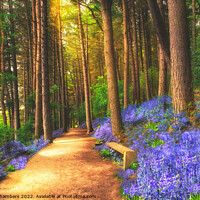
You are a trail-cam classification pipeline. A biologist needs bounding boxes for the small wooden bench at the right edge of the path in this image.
[106,142,137,171]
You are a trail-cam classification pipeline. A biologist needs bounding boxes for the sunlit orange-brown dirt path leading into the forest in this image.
[0,129,122,200]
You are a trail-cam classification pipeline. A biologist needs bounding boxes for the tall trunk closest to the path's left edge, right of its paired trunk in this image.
[41,0,53,142]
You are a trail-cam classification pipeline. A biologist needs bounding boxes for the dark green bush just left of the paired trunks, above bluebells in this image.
[16,120,35,146]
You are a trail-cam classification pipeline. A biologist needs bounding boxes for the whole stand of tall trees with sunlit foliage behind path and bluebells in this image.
[0,0,199,139]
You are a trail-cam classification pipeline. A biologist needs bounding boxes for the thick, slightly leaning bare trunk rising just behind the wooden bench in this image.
[100,0,123,138]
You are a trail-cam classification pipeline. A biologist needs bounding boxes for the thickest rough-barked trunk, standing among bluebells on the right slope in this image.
[168,0,194,113]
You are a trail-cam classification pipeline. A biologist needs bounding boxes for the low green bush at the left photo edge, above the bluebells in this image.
[0,123,14,146]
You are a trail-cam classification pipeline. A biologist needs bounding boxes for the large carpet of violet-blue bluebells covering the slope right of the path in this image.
[80,92,200,200]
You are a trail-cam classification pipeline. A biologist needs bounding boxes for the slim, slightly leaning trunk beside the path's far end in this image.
[77,0,93,134]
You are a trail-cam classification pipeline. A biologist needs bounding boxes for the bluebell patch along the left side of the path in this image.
[0,129,63,179]
